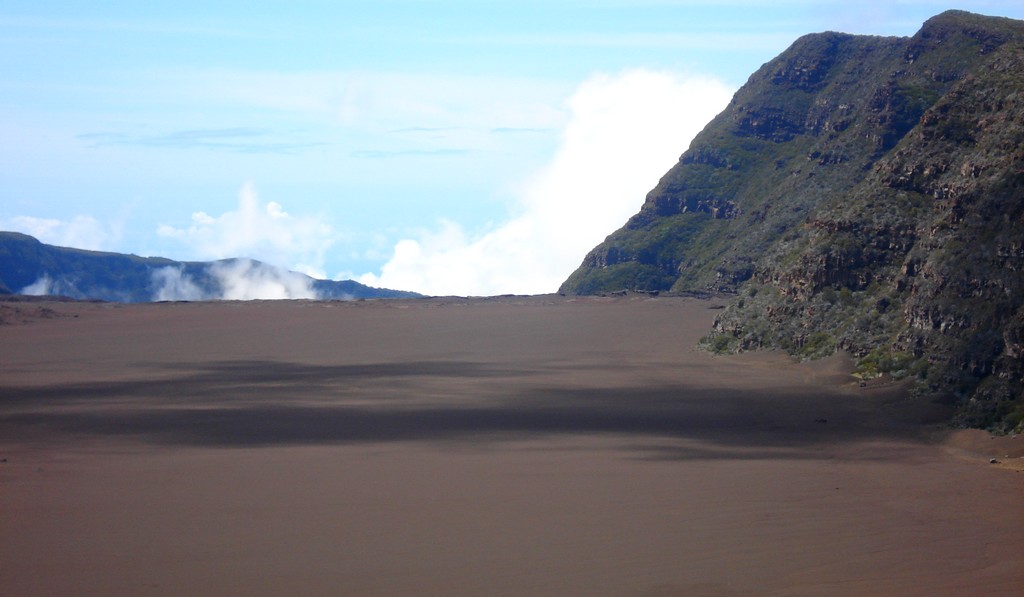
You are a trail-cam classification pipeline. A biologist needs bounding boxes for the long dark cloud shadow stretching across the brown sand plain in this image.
[0,360,947,458]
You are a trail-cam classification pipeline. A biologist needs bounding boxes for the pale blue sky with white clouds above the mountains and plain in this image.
[0,0,1024,296]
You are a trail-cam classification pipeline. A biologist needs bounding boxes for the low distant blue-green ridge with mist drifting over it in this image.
[0,231,420,302]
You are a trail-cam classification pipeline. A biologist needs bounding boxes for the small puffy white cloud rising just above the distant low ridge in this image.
[157,183,337,279]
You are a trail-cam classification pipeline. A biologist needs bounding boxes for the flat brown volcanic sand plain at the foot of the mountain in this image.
[0,297,1024,596]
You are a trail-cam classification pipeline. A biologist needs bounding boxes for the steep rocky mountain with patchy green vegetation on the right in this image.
[560,11,1024,430]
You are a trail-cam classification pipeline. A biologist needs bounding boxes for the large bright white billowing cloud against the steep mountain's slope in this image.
[359,70,734,295]
